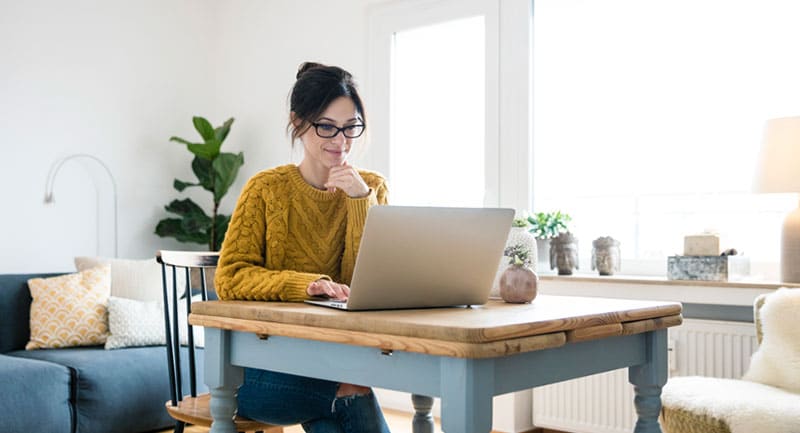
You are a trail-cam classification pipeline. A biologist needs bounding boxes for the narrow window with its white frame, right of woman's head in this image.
[365,0,516,207]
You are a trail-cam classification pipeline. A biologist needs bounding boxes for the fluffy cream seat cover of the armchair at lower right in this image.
[661,376,800,433]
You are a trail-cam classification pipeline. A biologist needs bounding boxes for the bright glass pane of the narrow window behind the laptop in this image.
[390,16,486,207]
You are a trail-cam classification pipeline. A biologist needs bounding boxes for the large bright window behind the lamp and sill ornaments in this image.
[532,0,800,279]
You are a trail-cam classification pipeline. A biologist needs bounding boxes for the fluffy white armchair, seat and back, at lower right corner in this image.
[662,288,800,433]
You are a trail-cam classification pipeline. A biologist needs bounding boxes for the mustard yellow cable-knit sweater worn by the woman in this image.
[215,165,387,301]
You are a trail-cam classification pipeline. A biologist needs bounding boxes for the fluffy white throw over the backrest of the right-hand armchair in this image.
[744,288,800,393]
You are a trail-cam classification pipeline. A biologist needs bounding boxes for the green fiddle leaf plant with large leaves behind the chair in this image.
[156,116,244,251]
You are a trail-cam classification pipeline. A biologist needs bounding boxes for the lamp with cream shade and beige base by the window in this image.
[755,116,800,283]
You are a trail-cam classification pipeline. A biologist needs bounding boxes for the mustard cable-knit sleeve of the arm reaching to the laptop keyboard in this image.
[214,173,330,302]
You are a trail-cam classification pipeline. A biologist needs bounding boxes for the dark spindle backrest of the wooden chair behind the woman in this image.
[156,250,219,406]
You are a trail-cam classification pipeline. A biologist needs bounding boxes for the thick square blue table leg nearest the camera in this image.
[440,358,494,433]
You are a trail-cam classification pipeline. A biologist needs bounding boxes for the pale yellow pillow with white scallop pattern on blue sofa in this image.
[25,265,111,350]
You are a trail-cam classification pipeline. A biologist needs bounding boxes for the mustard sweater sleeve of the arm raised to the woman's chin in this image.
[341,177,388,285]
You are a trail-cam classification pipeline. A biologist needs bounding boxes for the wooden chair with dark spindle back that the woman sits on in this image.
[156,250,283,433]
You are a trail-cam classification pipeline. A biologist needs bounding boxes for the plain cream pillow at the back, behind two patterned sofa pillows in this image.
[75,257,162,301]
